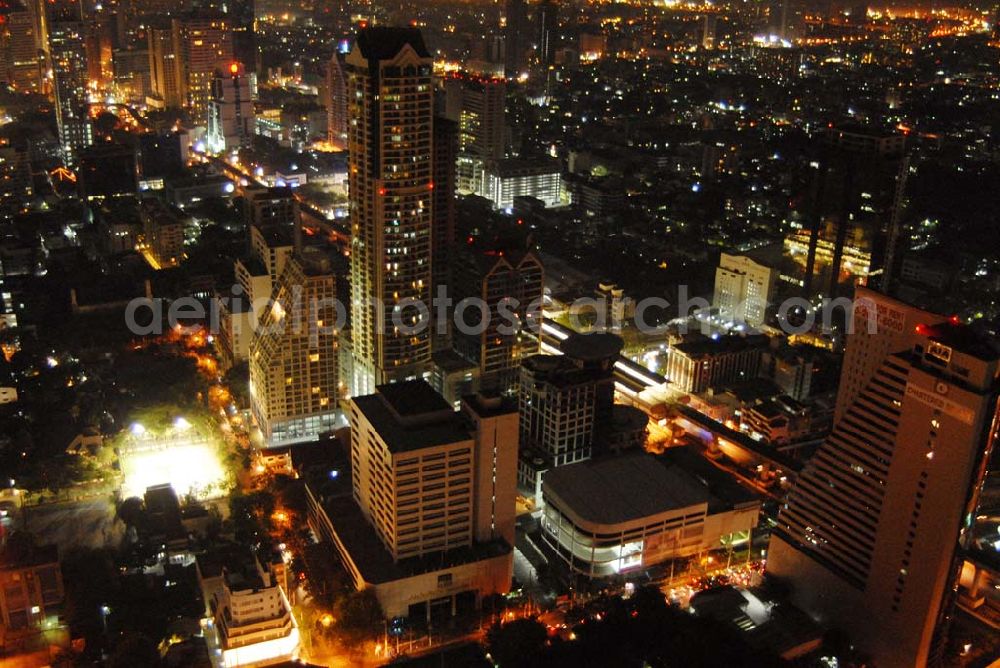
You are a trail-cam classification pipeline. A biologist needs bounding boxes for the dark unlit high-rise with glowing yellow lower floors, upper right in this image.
[803,128,909,297]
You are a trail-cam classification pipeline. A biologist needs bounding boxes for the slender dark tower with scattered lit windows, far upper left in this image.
[48,3,93,162]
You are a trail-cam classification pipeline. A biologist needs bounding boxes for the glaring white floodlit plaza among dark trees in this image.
[121,418,226,499]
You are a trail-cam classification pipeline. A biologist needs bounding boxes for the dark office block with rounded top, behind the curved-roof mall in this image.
[518,334,624,502]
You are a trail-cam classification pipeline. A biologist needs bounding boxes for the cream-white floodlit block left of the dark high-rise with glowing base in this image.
[712,253,778,327]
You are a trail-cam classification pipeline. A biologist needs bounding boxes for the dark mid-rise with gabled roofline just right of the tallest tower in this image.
[453,243,544,394]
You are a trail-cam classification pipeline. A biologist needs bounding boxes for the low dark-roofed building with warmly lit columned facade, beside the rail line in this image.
[666,334,769,394]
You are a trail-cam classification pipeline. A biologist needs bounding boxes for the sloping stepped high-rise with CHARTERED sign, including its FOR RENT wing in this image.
[767,294,1000,668]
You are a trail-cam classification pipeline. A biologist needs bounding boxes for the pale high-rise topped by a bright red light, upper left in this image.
[206,62,255,155]
